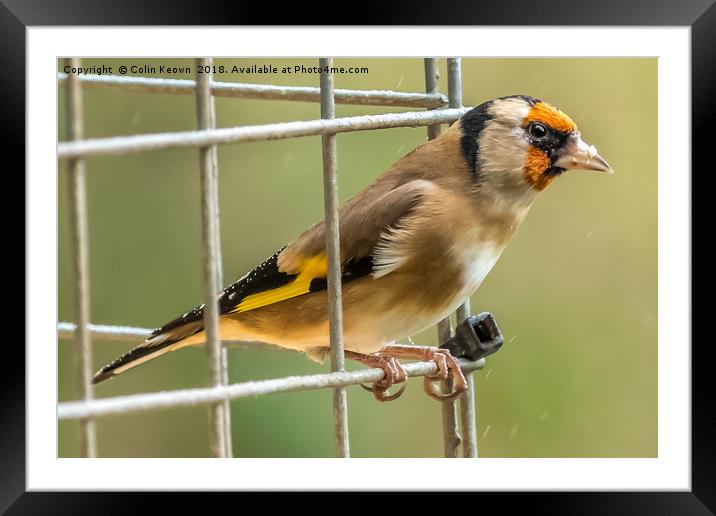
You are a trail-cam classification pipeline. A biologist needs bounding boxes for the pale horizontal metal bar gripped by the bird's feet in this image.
[57,359,485,420]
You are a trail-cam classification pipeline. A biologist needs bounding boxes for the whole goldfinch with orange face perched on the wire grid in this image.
[93,95,612,401]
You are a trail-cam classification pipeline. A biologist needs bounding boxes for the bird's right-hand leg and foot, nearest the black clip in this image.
[379,344,467,401]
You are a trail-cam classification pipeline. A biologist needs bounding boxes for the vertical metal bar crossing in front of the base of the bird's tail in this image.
[196,58,231,457]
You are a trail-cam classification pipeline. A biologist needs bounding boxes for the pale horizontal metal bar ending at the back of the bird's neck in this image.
[57,108,468,159]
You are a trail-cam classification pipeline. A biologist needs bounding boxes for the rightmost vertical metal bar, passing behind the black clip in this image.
[447,57,477,458]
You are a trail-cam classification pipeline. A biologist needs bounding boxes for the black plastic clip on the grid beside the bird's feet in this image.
[440,312,505,361]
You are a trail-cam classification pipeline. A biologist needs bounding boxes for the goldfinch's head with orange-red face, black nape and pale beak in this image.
[460,95,612,195]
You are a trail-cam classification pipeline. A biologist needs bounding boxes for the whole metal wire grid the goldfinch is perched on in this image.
[57,58,485,457]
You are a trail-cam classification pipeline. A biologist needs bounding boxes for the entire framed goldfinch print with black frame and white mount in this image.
[11,2,716,514]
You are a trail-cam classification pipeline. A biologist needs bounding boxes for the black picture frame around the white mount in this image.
[8,0,716,515]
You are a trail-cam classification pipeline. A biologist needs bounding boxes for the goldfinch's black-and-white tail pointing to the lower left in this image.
[92,321,203,384]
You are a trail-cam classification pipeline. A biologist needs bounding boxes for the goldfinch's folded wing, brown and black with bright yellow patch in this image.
[150,180,433,340]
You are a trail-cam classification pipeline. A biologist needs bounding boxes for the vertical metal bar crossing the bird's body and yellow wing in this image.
[319,57,350,457]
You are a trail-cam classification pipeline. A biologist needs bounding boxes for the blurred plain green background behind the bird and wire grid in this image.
[58,58,657,457]
